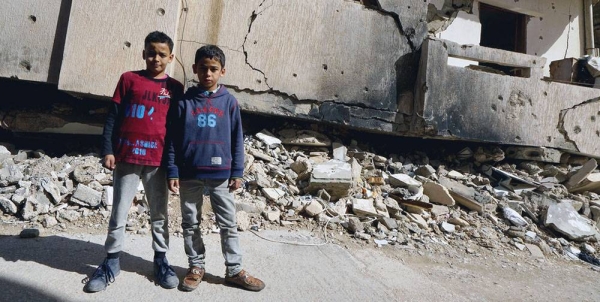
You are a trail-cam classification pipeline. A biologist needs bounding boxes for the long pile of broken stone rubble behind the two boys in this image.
[0,128,600,259]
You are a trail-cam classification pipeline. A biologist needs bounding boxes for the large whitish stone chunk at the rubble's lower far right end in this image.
[544,202,598,241]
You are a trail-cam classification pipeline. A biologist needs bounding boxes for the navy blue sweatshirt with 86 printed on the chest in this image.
[167,85,244,179]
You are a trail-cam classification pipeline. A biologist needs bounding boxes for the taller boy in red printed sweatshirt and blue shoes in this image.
[83,31,183,292]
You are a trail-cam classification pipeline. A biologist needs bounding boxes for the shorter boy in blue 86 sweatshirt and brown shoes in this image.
[167,45,265,291]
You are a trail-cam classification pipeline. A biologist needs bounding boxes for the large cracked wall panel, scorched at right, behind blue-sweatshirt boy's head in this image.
[174,0,426,132]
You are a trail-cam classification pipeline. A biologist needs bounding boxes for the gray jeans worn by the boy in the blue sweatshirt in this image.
[179,179,242,276]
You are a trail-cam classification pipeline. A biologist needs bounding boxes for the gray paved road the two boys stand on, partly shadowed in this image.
[0,231,469,302]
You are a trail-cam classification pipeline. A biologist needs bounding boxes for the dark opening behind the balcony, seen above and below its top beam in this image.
[479,2,527,76]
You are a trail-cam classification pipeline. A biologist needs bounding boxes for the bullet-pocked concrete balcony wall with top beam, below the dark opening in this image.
[413,40,600,156]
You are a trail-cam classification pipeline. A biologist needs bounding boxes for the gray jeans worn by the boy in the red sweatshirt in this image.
[104,162,169,253]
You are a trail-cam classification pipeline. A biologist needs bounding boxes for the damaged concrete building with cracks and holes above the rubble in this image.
[0,0,600,157]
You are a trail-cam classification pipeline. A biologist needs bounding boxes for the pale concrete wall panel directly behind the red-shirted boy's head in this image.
[58,0,180,97]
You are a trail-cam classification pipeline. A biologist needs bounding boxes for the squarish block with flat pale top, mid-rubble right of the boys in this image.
[306,160,353,201]
